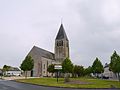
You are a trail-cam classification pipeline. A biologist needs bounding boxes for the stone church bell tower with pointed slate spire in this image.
[55,24,69,63]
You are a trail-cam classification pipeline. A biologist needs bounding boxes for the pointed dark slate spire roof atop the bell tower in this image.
[56,24,68,40]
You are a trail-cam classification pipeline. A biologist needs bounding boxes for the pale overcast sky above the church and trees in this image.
[0,0,120,67]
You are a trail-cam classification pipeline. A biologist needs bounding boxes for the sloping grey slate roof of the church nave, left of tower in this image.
[28,46,55,60]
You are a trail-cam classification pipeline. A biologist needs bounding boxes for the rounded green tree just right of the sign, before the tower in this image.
[62,58,73,82]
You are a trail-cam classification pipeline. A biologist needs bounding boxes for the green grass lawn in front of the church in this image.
[16,77,120,88]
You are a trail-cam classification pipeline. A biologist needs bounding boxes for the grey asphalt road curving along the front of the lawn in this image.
[0,80,120,90]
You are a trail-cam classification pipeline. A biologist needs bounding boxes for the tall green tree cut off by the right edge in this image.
[109,51,120,81]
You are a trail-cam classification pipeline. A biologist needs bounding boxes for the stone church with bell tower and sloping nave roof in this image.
[28,24,69,77]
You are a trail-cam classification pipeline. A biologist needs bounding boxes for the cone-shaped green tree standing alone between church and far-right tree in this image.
[92,57,104,77]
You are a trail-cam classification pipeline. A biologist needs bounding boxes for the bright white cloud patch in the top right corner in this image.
[101,0,120,24]
